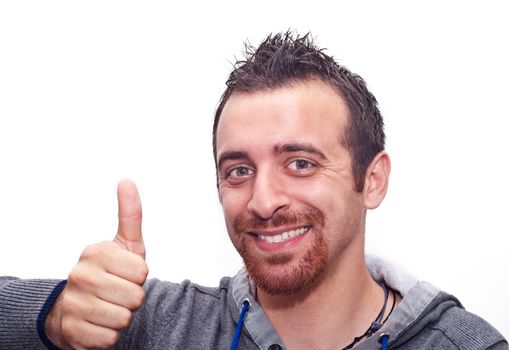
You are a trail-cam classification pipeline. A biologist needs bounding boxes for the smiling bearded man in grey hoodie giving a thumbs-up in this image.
[0,33,507,350]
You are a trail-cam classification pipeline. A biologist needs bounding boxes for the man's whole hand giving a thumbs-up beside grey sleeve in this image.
[45,180,148,350]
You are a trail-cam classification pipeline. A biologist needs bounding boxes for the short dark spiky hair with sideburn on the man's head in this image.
[213,31,385,192]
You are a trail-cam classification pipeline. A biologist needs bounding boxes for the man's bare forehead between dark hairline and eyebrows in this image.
[216,80,349,155]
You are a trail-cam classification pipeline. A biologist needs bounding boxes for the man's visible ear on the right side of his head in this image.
[362,151,391,209]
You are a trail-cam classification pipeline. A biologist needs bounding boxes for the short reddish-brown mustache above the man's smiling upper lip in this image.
[233,207,325,233]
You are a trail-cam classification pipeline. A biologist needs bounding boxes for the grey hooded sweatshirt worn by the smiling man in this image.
[0,258,509,350]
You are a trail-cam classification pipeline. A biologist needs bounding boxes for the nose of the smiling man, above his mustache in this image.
[247,169,290,220]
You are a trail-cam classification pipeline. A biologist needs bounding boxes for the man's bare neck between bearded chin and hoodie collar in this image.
[257,244,384,350]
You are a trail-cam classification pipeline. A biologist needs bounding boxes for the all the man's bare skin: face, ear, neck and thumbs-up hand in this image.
[45,81,397,350]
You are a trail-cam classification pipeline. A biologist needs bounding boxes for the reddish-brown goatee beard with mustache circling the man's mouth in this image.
[234,207,329,295]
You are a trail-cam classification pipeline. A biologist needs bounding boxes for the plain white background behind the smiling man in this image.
[0,0,509,337]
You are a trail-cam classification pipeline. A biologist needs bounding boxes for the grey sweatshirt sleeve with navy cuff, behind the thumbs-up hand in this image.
[0,277,65,350]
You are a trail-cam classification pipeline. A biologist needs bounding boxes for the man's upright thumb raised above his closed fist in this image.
[114,179,145,259]
